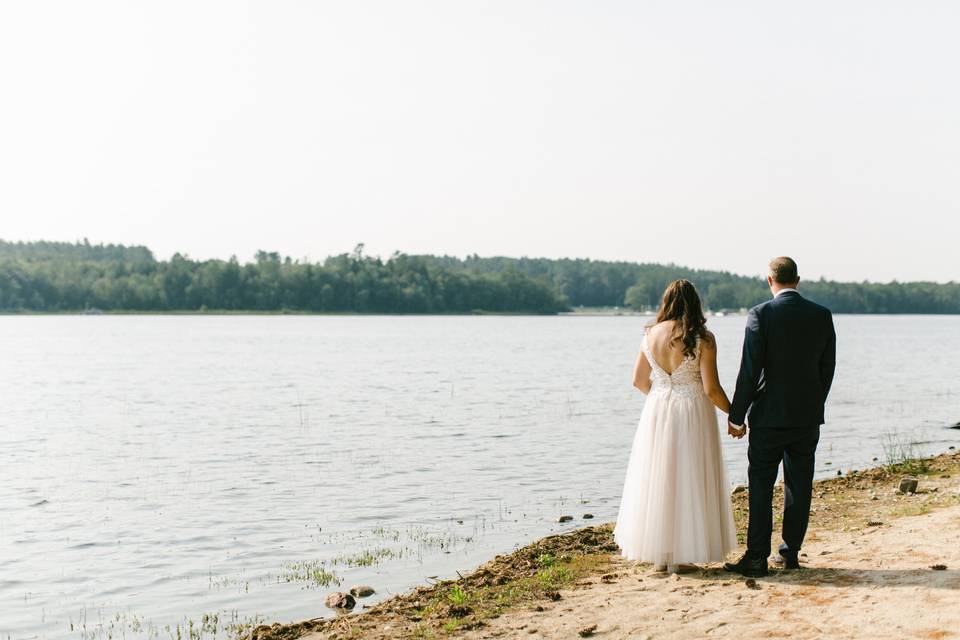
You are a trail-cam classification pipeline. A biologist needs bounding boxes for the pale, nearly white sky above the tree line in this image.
[0,0,960,281]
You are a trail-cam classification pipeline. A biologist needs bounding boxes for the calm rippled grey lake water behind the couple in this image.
[0,316,960,638]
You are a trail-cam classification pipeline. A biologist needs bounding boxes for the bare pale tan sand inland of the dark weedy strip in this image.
[464,506,960,639]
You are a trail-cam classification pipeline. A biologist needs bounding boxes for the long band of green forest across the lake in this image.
[0,240,960,314]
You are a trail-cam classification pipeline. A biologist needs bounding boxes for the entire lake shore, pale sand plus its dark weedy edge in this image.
[251,452,960,640]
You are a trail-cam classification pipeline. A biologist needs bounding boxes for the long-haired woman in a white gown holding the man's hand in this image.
[613,280,743,571]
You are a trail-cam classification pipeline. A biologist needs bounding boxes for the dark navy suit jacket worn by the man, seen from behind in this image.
[730,291,837,429]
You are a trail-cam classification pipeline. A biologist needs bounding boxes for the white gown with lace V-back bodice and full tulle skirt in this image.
[613,336,737,566]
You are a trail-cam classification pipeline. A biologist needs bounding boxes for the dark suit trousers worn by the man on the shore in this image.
[747,426,820,558]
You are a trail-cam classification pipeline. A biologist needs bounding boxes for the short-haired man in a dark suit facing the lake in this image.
[724,257,837,577]
